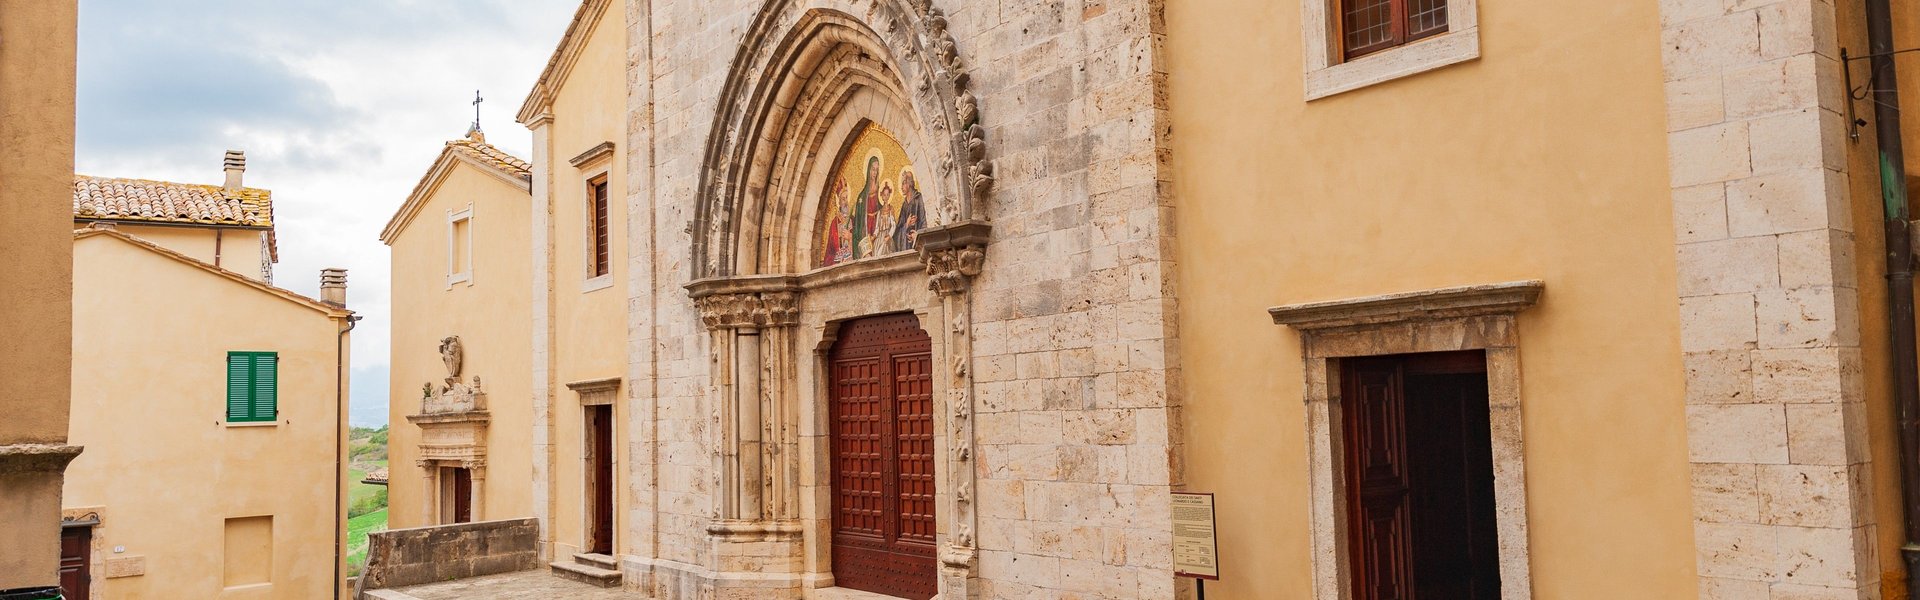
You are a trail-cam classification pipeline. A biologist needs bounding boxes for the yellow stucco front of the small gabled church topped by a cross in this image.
[388,163,534,527]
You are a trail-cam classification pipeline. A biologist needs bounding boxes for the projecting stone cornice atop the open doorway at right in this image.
[1267,279,1546,331]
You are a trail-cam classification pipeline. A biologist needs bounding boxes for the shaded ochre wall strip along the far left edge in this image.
[0,0,79,590]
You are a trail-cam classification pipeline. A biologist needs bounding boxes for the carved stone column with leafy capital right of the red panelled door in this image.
[918,221,991,598]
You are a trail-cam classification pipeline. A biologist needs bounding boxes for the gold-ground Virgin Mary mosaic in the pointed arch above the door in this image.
[816,125,927,267]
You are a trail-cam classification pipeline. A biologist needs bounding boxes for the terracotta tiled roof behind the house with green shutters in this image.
[73,175,273,229]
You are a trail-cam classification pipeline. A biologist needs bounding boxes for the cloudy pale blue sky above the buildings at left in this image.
[77,0,578,425]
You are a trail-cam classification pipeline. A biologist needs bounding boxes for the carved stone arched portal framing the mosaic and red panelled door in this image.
[687,0,993,598]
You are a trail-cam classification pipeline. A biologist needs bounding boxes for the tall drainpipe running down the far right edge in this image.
[1866,0,1920,600]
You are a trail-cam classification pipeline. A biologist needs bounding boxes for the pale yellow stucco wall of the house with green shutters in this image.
[65,235,346,600]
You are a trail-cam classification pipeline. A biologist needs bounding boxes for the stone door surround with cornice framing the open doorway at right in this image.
[1267,281,1546,600]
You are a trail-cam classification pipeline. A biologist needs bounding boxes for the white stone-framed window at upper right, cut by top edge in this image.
[1300,0,1480,100]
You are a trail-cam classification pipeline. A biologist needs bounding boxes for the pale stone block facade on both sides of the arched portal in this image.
[622,0,1181,598]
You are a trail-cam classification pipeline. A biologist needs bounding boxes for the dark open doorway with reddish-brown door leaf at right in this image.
[1340,350,1500,600]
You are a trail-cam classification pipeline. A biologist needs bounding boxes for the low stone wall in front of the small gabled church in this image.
[361,519,540,590]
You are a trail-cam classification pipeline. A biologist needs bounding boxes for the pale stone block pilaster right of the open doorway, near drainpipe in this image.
[1661,0,1880,598]
